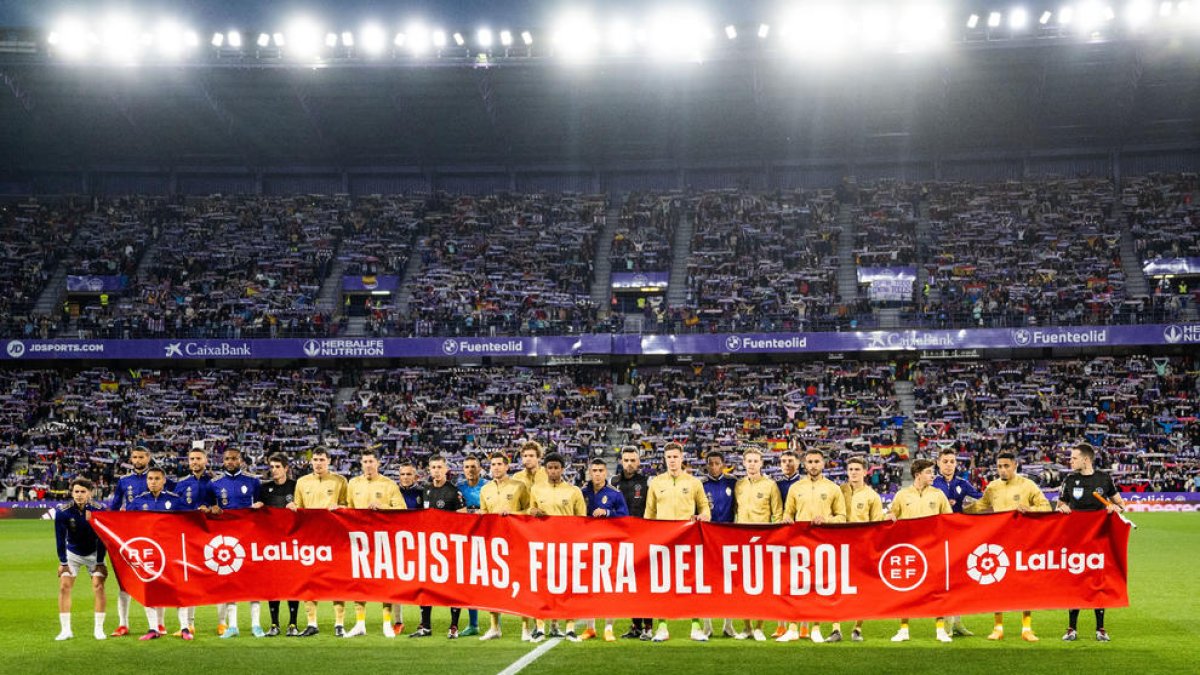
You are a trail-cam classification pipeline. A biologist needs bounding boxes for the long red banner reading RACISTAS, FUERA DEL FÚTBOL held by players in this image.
[94,509,1129,621]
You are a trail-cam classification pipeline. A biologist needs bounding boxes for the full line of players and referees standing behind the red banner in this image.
[55,441,1124,643]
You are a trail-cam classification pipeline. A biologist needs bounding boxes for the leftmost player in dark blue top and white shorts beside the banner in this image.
[54,478,108,640]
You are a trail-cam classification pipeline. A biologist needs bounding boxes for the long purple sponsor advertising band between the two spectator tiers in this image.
[7,323,1200,360]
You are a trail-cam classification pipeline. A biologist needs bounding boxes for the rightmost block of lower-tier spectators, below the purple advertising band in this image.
[912,356,1200,491]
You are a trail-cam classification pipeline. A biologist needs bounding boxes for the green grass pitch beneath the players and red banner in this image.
[0,513,1200,675]
